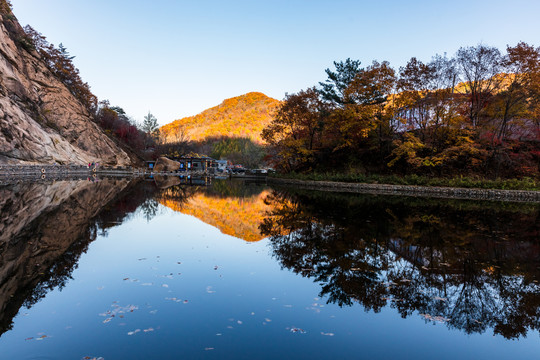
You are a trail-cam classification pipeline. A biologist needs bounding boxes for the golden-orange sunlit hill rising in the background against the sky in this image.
[160,92,280,143]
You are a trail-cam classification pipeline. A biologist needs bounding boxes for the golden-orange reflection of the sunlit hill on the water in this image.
[159,191,270,241]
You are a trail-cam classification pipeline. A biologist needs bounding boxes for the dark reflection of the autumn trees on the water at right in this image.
[260,192,540,338]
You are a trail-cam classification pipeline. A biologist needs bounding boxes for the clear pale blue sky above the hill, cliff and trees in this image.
[11,0,540,125]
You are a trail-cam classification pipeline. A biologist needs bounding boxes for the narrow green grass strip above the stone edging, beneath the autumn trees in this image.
[272,173,540,191]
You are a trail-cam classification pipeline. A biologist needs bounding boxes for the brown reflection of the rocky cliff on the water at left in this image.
[0,179,150,333]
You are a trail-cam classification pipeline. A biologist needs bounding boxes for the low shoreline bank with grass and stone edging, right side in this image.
[267,177,540,203]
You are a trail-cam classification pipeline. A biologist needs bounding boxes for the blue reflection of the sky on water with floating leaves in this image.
[0,206,539,359]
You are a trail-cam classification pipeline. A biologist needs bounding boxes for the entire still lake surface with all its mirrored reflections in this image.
[0,178,540,360]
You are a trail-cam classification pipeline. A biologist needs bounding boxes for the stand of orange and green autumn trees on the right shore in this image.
[262,42,540,179]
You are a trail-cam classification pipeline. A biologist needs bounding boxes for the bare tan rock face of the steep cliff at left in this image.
[0,13,131,166]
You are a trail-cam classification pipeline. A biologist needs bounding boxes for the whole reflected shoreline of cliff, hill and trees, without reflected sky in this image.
[0,177,540,339]
